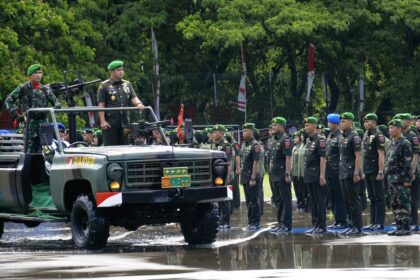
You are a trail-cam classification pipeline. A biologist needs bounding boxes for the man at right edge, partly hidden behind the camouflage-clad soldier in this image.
[396,113,420,231]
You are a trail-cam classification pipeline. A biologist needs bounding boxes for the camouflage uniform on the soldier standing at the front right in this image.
[386,137,413,227]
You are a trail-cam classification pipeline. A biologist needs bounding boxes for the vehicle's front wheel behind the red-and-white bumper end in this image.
[71,195,109,249]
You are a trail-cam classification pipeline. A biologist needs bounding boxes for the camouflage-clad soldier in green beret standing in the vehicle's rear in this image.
[5,64,61,153]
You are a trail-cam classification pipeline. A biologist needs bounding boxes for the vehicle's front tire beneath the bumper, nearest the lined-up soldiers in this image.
[181,203,219,245]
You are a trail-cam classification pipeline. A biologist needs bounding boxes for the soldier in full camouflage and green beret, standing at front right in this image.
[386,119,413,236]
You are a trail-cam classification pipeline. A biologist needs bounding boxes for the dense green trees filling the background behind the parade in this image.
[0,0,420,125]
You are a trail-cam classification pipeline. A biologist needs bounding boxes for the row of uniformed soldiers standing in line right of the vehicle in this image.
[195,112,420,236]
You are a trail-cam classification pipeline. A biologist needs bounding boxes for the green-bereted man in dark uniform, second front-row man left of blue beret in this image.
[269,117,292,233]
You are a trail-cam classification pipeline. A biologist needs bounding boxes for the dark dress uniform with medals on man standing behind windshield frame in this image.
[97,79,137,146]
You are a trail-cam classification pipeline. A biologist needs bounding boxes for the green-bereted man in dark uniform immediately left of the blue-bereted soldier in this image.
[303,117,327,234]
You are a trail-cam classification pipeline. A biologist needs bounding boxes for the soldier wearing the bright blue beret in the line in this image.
[326,114,347,229]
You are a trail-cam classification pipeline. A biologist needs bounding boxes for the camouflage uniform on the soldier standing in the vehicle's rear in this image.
[5,82,60,153]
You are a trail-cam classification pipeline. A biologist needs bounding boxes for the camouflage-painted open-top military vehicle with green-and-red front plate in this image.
[0,107,231,249]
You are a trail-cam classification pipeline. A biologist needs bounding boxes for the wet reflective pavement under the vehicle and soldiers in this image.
[0,202,420,279]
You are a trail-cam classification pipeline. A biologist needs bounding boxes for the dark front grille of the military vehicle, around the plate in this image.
[125,159,211,188]
